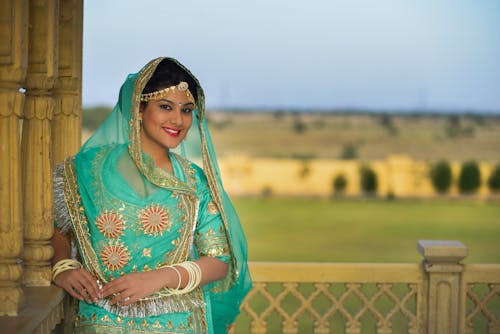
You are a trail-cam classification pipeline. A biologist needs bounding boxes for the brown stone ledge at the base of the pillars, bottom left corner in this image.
[0,285,64,334]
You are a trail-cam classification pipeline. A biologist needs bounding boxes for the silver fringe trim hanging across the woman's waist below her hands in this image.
[95,295,205,318]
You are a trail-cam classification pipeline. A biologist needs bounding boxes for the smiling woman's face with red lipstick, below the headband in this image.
[140,89,195,152]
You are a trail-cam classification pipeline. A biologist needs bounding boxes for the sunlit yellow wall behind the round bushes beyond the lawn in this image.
[219,155,493,198]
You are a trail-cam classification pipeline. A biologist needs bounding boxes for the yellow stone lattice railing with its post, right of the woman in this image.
[232,241,500,334]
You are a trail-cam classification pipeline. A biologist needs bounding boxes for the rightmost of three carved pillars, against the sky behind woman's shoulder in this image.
[52,0,83,164]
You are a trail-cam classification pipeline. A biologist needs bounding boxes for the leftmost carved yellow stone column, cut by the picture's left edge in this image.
[0,0,28,316]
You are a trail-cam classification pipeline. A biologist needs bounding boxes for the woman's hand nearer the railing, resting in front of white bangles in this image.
[102,270,167,306]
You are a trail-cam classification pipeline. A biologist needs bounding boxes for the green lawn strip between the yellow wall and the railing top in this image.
[234,198,500,263]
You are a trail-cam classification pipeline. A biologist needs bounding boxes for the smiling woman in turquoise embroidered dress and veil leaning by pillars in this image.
[52,58,251,333]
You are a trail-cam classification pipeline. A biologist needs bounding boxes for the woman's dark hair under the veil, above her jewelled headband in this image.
[142,58,198,102]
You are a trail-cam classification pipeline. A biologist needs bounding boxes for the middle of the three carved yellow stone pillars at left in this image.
[21,0,59,286]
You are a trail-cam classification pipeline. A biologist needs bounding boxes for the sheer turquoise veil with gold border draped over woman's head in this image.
[74,57,251,333]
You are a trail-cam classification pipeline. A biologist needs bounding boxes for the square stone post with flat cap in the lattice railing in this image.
[418,240,467,334]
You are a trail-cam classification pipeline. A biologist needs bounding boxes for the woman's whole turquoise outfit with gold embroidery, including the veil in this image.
[54,58,251,333]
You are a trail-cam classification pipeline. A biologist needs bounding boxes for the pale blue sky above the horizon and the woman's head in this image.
[83,0,500,113]
